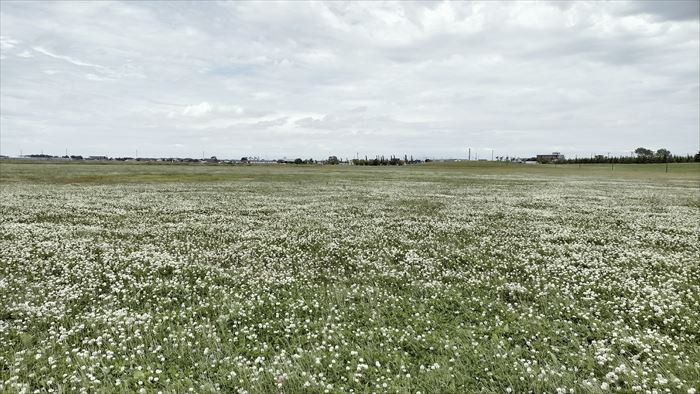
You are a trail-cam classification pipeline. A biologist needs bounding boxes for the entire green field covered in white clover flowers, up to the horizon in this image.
[0,161,700,393]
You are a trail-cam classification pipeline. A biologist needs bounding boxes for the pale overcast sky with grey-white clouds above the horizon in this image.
[0,0,700,159]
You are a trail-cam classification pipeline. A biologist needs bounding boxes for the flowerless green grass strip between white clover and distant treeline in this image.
[0,160,700,184]
